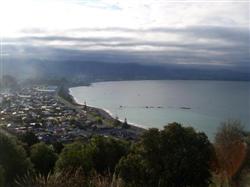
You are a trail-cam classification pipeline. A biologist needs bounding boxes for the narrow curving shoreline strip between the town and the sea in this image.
[57,87,147,135]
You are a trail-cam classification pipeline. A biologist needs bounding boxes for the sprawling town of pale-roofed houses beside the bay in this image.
[0,87,139,143]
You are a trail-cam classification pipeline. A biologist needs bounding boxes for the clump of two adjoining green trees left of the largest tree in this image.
[56,136,129,175]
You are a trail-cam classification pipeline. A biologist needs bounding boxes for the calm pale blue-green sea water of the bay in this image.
[70,80,250,138]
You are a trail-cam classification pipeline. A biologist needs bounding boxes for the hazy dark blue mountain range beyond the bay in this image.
[4,59,250,83]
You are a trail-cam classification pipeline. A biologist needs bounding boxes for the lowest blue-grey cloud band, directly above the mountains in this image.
[4,42,249,68]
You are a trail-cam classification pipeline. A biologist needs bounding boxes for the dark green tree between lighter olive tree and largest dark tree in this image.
[90,136,129,173]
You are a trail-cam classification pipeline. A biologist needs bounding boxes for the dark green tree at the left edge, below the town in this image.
[0,132,32,186]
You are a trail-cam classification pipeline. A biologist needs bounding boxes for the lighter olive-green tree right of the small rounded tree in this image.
[56,142,93,175]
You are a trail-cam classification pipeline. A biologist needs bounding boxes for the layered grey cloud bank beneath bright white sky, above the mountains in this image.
[8,26,250,68]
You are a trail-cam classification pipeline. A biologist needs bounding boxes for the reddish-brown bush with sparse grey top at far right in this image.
[214,120,250,186]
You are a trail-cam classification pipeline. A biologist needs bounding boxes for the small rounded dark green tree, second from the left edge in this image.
[30,143,57,176]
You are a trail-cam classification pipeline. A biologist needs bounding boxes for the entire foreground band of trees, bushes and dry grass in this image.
[0,121,250,187]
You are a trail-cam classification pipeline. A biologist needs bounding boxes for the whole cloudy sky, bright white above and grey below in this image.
[0,0,250,68]
